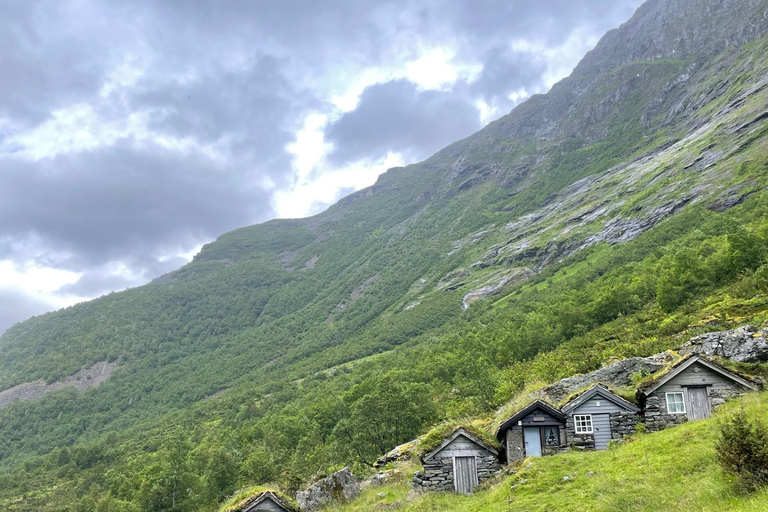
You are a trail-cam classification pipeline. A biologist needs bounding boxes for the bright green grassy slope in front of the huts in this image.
[329,392,768,512]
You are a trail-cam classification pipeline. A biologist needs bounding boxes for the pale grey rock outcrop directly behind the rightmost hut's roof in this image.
[679,325,768,363]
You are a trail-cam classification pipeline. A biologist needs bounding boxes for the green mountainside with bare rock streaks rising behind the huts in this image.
[0,0,768,510]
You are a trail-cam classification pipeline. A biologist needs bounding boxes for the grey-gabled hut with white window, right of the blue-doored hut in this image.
[562,385,640,450]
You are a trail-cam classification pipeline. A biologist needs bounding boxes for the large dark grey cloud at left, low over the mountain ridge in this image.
[0,140,271,271]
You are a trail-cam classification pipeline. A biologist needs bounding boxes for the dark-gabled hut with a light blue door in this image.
[496,400,568,463]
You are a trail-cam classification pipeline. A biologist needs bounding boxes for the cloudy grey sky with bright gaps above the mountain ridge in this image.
[0,0,642,333]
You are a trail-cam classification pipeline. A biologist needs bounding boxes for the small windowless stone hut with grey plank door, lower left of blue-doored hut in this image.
[413,428,502,494]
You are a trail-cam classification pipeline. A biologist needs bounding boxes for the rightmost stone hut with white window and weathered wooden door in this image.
[637,355,758,432]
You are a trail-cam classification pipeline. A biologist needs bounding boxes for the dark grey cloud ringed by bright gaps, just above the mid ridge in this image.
[328,80,480,164]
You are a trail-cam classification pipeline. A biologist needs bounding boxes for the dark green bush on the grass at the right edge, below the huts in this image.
[715,409,768,491]
